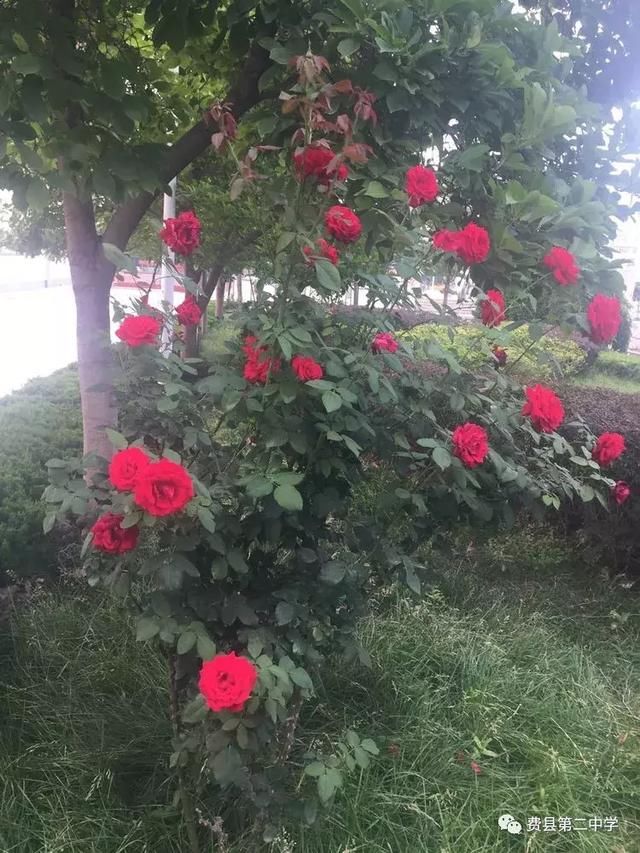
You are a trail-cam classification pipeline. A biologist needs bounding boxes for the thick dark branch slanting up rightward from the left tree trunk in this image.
[103,42,271,250]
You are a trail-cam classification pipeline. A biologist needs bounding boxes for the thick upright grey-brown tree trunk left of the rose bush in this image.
[64,194,117,459]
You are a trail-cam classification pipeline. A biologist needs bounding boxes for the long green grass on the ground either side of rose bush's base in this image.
[0,531,640,853]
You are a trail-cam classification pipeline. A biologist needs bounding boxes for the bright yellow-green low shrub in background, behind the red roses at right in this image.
[404,323,588,380]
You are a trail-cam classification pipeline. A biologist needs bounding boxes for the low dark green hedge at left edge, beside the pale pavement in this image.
[0,368,82,580]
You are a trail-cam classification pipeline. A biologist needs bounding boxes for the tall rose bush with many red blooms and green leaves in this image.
[45,41,614,850]
